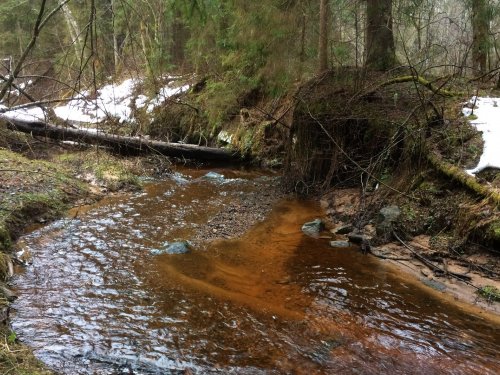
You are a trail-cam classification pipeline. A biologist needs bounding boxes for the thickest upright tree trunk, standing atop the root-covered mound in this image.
[365,0,396,70]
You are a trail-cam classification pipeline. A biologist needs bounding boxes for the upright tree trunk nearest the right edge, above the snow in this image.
[471,0,489,76]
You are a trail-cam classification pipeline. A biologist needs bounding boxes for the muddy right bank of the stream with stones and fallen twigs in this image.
[322,187,500,317]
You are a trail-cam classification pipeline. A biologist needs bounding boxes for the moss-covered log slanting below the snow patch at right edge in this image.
[427,152,500,205]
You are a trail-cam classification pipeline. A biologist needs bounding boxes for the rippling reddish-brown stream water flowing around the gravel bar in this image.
[7,170,500,374]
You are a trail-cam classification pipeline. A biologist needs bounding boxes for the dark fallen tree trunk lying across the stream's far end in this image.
[0,114,242,162]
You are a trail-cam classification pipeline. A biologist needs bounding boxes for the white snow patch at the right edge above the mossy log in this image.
[462,96,500,175]
